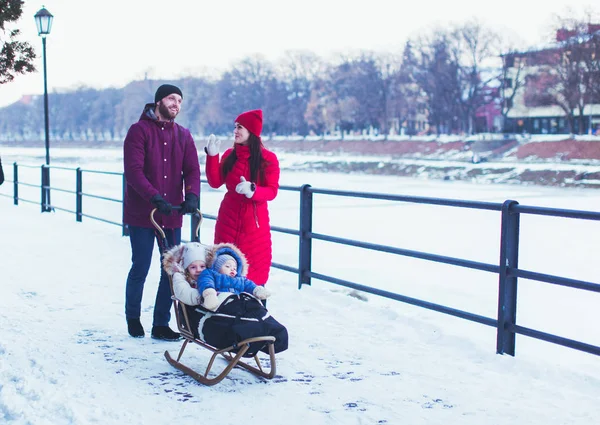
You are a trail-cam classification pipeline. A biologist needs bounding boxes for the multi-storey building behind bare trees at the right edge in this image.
[503,24,600,134]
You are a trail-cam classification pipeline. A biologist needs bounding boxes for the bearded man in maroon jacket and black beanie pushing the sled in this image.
[123,84,200,341]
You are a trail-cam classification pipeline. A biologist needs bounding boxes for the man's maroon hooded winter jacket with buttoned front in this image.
[123,103,200,229]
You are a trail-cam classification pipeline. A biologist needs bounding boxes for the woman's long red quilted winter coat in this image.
[206,145,279,285]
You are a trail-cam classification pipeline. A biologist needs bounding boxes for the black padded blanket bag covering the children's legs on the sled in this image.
[188,292,288,357]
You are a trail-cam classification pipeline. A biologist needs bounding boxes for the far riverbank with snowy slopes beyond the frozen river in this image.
[0,136,600,189]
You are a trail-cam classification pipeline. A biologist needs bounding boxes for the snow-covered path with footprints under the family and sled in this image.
[0,198,600,425]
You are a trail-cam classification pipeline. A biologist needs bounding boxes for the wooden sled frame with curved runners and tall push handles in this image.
[150,207,276,385]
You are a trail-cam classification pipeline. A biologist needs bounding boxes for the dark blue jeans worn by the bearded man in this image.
[125,226,181,326]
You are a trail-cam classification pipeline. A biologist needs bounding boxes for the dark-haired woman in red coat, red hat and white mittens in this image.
[206,109,279,285]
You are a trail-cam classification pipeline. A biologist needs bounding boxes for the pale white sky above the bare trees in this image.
[0,0,597,107]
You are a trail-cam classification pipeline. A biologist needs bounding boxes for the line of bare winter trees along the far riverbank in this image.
[0,3,600,141]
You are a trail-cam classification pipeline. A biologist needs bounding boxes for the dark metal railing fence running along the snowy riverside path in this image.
[0,163,600,356]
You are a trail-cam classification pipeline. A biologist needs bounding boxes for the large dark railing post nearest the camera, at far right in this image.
[496,200,520,356]
